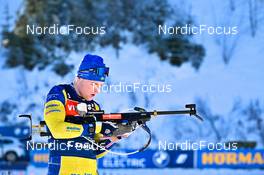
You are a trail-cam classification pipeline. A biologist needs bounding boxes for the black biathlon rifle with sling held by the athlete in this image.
[19,103,203,153]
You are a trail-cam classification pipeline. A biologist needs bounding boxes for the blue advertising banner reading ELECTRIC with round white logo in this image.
[98,150,194,169]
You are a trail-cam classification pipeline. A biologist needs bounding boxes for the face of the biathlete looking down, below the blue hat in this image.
[75,77,104,101]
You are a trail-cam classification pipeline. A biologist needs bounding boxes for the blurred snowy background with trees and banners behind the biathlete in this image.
[0,0,264,175]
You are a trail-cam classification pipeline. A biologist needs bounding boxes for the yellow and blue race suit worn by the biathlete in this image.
[44,84,116,175]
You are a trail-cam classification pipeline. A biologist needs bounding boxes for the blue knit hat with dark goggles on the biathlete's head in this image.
[77,54,109,82]
